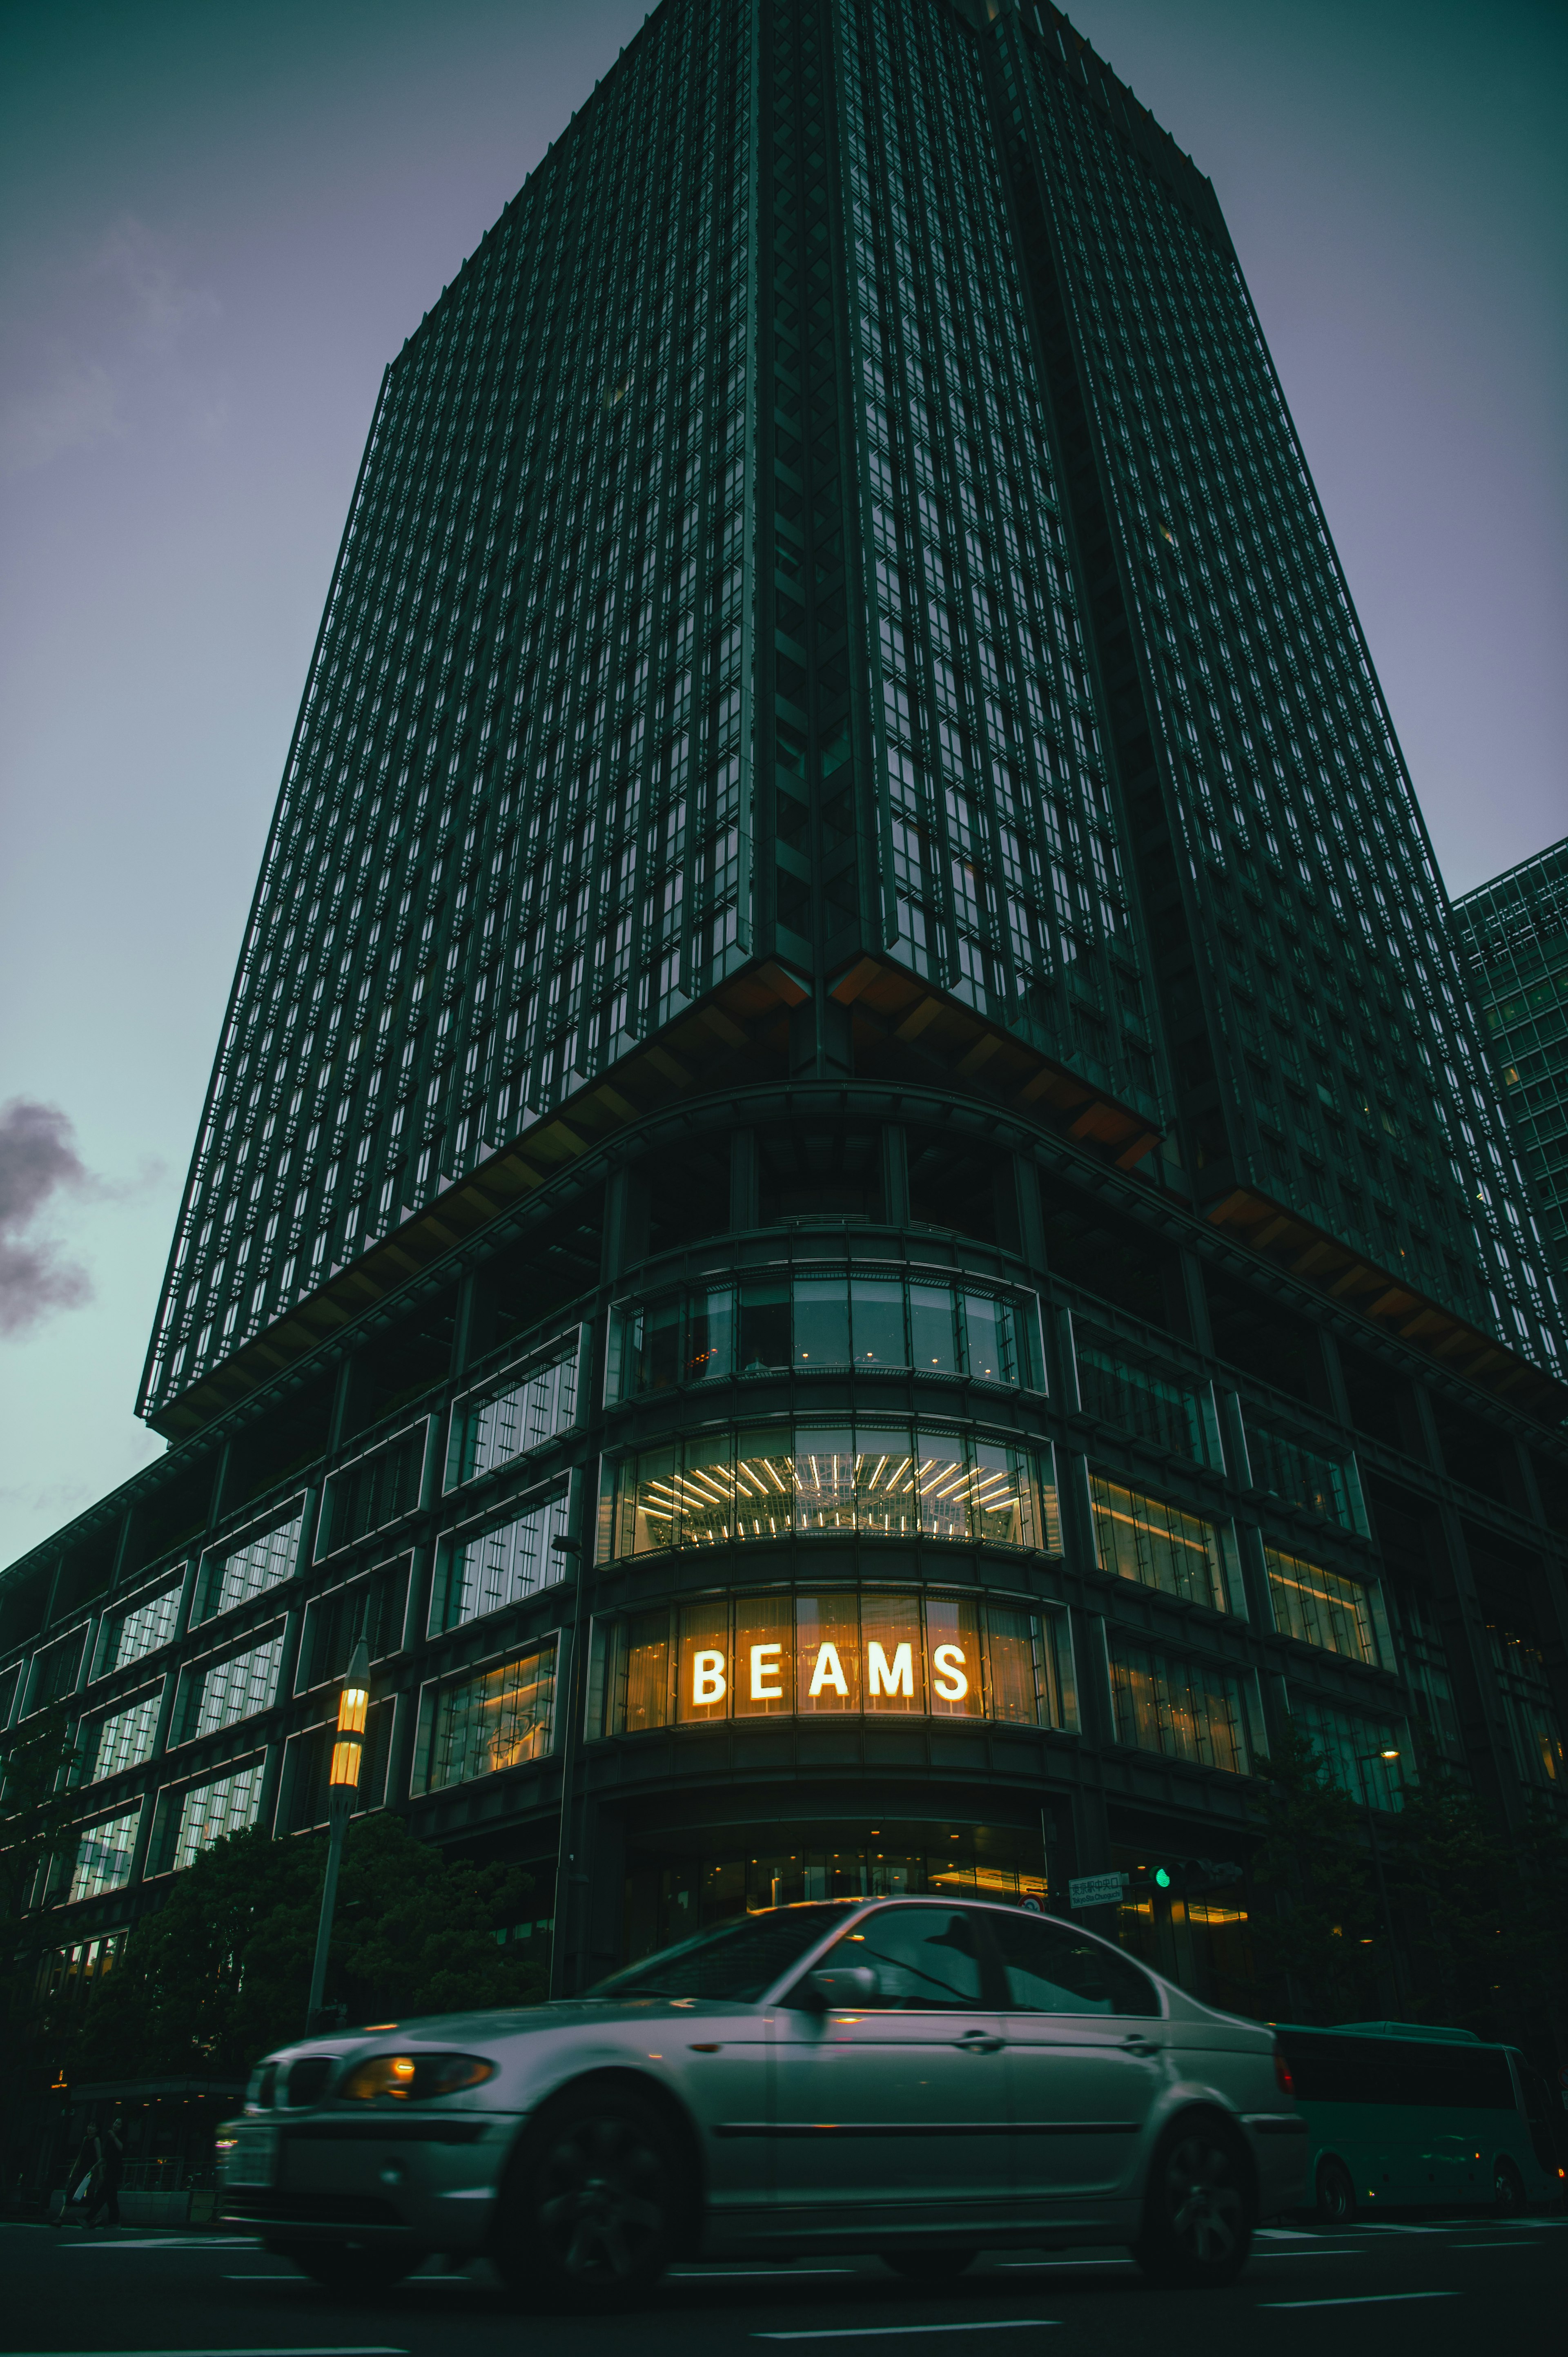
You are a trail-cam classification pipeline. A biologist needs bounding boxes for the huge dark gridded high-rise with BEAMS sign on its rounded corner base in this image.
[0,0,1568,2036]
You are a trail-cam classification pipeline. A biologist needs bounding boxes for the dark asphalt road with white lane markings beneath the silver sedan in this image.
[0,2218,1568,2357]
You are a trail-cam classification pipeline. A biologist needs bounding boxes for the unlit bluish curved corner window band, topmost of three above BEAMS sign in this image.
[608,1268,1045,1400]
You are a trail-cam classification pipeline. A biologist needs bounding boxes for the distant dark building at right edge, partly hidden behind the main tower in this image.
[1455,837,1568,1292]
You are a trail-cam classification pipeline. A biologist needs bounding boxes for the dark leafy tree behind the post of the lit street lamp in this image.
[71,1810,545,2079]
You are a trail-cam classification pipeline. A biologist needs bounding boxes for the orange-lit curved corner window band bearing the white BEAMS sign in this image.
[590,1589,1078,1735]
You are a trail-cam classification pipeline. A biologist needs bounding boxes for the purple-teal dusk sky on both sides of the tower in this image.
[0,0,1568,1565]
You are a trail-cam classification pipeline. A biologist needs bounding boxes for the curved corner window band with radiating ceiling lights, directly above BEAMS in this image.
[599,1419,1061,1560]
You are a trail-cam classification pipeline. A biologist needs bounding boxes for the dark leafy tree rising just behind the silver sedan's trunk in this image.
[1252,1721,1379,2023]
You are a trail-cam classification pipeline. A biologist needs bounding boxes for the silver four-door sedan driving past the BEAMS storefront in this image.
[219,1900,1306,2308]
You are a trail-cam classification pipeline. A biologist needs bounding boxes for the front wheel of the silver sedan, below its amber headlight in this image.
[490,2086,691,2310]
